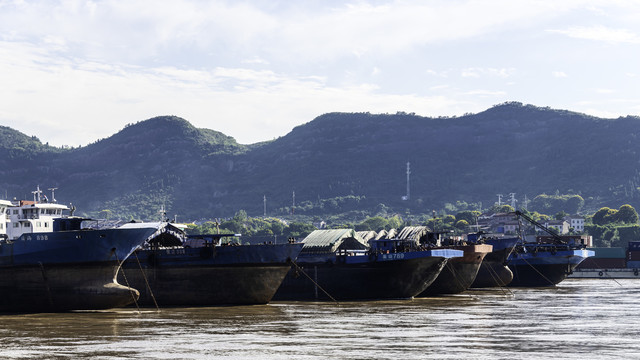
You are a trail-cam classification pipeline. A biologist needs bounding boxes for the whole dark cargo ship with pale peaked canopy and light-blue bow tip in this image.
[274,229,463,301]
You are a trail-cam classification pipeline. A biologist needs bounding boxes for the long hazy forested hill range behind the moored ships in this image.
[0,103,640,220]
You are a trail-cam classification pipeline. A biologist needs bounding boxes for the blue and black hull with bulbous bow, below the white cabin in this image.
[0,226,158,312]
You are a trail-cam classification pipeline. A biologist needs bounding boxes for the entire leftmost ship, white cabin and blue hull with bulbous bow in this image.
[0,188,163,312]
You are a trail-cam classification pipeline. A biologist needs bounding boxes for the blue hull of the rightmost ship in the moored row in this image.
[508,250,593,287]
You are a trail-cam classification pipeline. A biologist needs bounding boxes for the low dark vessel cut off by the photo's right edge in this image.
[569,241,640,279]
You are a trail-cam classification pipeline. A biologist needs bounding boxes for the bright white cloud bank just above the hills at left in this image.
[0,38,470,146]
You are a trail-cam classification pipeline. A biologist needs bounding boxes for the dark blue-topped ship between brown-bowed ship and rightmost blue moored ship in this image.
[467,234,520,288]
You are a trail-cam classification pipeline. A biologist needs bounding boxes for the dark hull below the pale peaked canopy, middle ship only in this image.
[274,254,447,301]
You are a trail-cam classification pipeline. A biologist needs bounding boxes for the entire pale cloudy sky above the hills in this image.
[0,0,640,146]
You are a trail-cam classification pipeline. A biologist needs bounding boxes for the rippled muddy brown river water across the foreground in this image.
[0,279,640,359]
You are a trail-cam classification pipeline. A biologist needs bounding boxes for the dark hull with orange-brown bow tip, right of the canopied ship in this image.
[419,245,492,297]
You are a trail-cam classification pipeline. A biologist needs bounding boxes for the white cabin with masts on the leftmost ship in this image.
[4,189,70,240]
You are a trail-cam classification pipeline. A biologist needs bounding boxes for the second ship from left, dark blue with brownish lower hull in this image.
[119,229,302,307]
